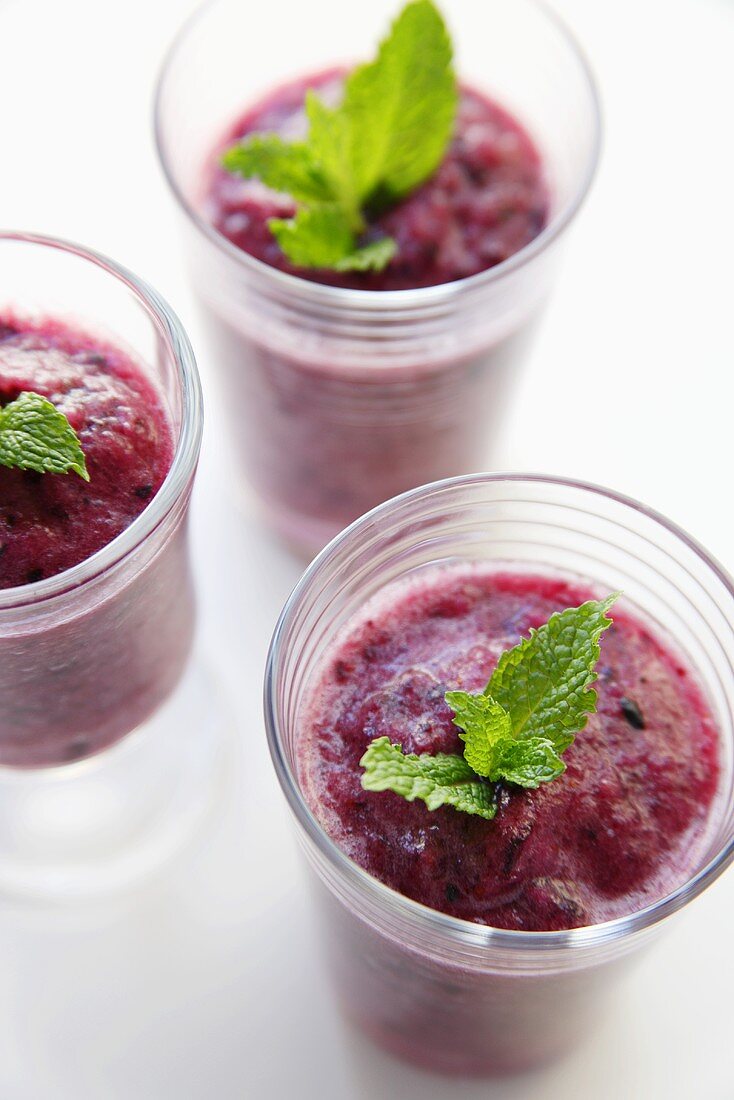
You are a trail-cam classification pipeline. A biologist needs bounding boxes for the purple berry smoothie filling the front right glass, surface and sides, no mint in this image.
[294,565,720,1076]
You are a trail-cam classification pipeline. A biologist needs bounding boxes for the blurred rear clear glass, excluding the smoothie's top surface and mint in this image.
[155,0,600,552]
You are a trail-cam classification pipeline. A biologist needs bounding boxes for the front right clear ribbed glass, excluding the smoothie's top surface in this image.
[265,474,734,1074]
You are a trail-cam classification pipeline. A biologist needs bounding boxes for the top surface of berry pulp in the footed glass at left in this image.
[0,316,173,589]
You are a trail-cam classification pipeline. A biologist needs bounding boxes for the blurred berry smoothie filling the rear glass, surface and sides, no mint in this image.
[196,72,551,551]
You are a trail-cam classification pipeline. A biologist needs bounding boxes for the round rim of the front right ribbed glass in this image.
[263,473,734,955]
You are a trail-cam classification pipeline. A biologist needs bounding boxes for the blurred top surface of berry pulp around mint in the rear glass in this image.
[206,70,548,290]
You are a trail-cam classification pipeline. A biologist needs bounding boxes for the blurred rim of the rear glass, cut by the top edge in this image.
[153,0,602,315]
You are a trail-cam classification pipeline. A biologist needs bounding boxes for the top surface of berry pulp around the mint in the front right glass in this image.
[299,570,720,931]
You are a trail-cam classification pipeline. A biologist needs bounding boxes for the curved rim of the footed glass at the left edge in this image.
[0,229,204,613]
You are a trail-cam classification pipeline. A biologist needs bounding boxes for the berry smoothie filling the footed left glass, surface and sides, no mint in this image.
[0,314,193,768]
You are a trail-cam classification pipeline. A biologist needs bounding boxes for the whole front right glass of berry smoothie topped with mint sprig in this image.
[265,475,734,1073]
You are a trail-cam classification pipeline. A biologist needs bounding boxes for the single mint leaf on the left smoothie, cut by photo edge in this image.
[0,393,89,481]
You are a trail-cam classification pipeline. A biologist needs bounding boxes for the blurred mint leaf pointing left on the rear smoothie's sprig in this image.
[217,134,333,202]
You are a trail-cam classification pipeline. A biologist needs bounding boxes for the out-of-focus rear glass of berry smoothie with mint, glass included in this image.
[156,0,599,553]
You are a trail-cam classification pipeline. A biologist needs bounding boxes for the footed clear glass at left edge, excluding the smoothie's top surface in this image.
[0,232,215,895]
